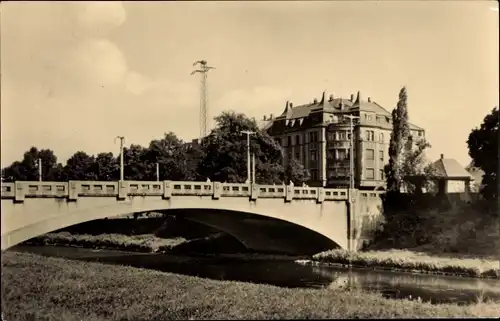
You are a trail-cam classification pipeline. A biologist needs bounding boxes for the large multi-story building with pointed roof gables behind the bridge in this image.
[264,92,425,189]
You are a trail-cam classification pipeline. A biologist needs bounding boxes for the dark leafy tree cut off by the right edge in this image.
[467,107,499,200]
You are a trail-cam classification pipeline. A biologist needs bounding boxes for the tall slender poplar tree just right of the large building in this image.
[385,87,410,192]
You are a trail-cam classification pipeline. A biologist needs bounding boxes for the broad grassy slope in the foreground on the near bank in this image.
[2,252,500,321]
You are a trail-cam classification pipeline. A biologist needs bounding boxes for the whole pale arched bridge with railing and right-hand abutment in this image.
[1,181,381,253]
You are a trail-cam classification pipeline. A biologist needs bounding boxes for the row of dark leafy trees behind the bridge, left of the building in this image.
[2,111,310,185]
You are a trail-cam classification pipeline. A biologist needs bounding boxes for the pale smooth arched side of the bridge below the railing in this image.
[2,196,347,250]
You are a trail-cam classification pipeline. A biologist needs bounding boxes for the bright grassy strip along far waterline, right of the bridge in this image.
[311,250,500,279]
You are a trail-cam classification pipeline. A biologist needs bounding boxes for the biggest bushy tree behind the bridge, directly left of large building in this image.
[198,112,292,184]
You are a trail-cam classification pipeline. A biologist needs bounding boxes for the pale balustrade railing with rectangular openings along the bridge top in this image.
[1,181,358,202]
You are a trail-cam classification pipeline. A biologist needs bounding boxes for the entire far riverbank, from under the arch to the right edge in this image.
[26,232,500,279]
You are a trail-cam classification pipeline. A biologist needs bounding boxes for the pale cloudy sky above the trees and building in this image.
[0,0,499,167]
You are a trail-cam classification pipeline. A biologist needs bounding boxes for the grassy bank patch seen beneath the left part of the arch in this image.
[26,232,186,252]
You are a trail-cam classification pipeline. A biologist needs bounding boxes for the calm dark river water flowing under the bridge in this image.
[13,246,500,304]
